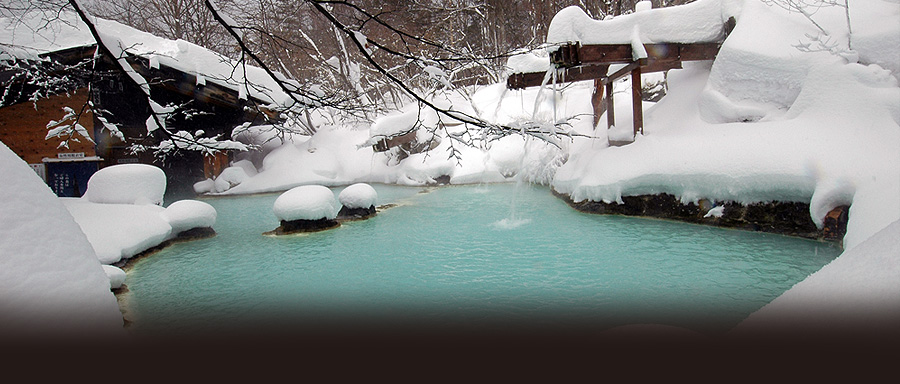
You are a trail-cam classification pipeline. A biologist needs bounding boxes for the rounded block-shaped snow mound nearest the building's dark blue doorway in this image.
[84,164,166,205]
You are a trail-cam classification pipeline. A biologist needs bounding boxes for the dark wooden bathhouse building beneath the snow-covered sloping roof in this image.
[0,39,275,197]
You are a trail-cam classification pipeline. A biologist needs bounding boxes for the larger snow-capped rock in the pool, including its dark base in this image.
[272,185,339,234]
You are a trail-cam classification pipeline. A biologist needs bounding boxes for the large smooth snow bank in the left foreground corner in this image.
[0,143,122,338]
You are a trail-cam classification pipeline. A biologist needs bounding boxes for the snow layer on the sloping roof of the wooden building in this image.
[0,12,289,105]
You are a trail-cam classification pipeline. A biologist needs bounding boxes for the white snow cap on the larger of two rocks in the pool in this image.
[272,185,338,221]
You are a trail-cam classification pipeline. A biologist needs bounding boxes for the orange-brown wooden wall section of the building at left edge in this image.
[0,88,96,164]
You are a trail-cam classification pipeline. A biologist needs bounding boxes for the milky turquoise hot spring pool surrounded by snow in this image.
[123,184,840,334]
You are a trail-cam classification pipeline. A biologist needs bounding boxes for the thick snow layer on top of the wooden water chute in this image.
[547,0,742,44]
